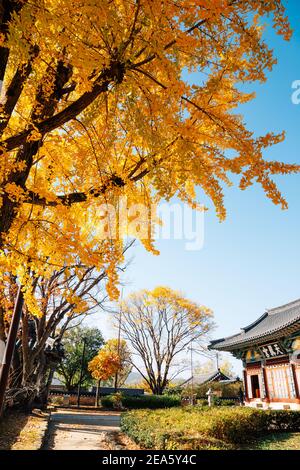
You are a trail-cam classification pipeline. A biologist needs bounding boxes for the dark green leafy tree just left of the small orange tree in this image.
[58,326,104,391]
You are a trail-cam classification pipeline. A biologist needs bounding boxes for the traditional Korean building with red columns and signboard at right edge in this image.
[209,300,300,410]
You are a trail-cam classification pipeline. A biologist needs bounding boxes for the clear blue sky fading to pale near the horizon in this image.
[88,0,300,373]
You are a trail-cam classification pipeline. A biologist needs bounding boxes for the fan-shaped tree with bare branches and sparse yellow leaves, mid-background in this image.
[116,287,213,395]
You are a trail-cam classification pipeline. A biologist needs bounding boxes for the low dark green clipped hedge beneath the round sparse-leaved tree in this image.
[101,395,181,410]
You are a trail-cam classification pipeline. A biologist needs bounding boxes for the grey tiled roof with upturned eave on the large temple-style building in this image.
[209,299,300,351]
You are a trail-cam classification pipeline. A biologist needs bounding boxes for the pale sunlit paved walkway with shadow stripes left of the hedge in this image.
[45,411,120,450]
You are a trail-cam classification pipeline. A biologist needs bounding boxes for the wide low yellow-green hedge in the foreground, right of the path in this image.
[121,407,300,450]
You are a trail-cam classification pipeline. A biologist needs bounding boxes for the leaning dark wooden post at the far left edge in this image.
[0,286,24,418]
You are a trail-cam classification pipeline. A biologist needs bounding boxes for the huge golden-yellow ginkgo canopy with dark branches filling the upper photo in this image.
[0,0,299,306]
